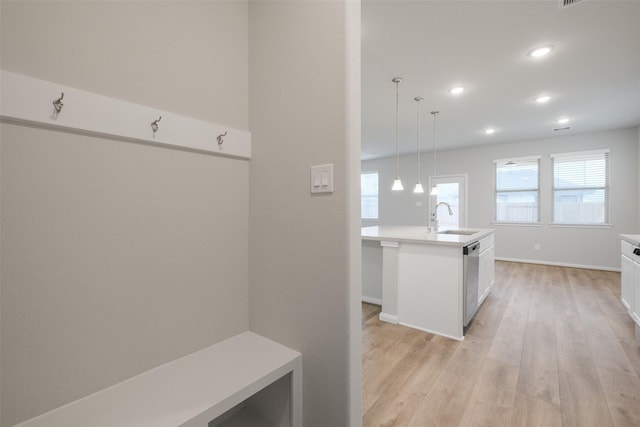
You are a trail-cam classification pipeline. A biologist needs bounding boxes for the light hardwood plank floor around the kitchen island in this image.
[362,262,640,427]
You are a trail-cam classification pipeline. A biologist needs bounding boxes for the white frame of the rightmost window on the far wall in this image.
[549,148,612,228]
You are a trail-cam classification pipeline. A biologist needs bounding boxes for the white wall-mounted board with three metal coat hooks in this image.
[0,70,251,159]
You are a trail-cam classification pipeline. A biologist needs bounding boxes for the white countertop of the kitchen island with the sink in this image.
[361,225,495,247]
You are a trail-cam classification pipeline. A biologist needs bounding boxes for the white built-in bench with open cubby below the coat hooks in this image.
[14,332,302,427]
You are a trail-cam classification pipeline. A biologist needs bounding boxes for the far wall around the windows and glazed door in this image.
[362,128,640,269]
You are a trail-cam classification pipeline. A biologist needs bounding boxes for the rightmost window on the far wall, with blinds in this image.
[551,150,609,225]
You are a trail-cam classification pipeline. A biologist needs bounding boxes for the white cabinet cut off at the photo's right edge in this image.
[620,234,640,344]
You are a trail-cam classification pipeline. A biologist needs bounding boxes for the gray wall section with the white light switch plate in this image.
[249,1,361,427]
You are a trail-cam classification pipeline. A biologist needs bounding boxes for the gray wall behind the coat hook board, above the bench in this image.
[0,1,249,426]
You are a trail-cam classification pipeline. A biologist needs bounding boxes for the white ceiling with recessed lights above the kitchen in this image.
[362,0,640,159]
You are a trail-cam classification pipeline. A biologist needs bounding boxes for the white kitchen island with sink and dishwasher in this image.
[361,226,495,340]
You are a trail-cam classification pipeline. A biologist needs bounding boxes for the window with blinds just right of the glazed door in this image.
[493,156,540,223]
